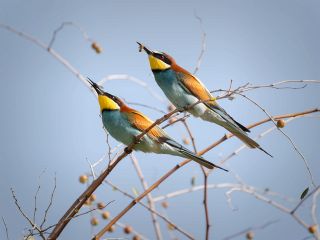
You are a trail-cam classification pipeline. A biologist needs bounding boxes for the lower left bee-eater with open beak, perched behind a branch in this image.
[88,79,228,171]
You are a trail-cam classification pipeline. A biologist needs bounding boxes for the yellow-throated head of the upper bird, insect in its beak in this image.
[137,42,175,71]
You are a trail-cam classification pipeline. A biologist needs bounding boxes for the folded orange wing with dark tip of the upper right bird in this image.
[175,67,250,132]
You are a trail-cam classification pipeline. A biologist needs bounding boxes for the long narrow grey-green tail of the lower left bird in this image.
[166,139,228,172]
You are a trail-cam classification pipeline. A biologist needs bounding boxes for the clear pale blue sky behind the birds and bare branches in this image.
[0,0,320,239]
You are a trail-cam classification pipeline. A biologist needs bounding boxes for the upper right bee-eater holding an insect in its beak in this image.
[137,42,272,157]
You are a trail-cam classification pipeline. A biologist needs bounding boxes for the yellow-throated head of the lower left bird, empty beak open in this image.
[88,78,123,112]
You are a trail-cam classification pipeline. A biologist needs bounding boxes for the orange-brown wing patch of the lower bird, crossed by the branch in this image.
[121,107,169,142]
